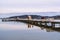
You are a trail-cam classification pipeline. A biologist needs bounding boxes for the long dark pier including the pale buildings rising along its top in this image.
[2,16,60,29]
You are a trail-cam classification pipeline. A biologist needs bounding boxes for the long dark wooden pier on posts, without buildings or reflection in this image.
[2,19,60,28]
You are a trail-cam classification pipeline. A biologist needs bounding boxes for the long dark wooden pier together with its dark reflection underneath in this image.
[2,18,60,32]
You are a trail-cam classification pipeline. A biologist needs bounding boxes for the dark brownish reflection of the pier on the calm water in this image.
[2,21,60,32]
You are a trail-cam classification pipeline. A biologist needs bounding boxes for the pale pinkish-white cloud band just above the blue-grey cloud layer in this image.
[0,7,60,13]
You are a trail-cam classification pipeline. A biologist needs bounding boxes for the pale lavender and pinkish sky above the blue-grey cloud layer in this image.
[0,0,60,13]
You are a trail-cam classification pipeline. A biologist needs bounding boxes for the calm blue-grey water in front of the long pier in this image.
[0,20,60,40]
